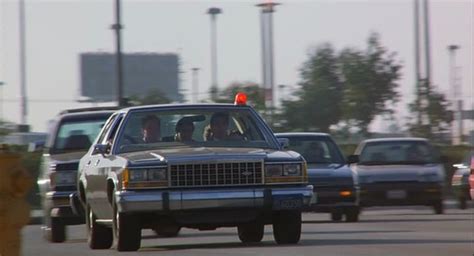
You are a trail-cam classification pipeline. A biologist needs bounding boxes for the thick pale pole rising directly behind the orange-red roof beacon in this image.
[256,1,280,123]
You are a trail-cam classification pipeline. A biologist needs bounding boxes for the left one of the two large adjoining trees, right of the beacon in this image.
[282,43,343,132]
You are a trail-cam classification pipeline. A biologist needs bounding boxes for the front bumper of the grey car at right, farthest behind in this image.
[360,182,443,206]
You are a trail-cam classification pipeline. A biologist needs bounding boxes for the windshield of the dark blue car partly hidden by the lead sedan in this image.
[279,136,345,164]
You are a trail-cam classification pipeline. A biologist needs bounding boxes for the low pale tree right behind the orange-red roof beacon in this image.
[215,82,265,111]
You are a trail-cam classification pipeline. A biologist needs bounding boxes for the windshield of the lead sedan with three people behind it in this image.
[116,108,278,153]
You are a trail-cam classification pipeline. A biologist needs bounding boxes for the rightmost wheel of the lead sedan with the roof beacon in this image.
[273,211,301,244]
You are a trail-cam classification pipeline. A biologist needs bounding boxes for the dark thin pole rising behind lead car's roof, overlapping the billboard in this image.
[112,0,124,107]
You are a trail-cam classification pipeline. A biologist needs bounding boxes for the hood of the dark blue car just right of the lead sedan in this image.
[308,164,353,187]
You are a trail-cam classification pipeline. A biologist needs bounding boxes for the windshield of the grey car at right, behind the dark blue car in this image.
[359,141,438,165]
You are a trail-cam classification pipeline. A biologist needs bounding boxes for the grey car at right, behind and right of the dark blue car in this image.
[349,138,445,214]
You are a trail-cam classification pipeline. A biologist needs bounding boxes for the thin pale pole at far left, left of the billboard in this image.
[19,0,28,125]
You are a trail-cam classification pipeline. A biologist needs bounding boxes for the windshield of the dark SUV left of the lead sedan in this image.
[50,116,109,154]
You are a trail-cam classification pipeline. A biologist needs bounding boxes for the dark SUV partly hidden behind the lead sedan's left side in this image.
[38,107,116,243]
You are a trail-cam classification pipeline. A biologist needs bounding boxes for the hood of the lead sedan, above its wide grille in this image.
[121,147,301,164]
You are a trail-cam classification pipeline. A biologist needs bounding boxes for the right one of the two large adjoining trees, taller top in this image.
[339,33,402,134]
